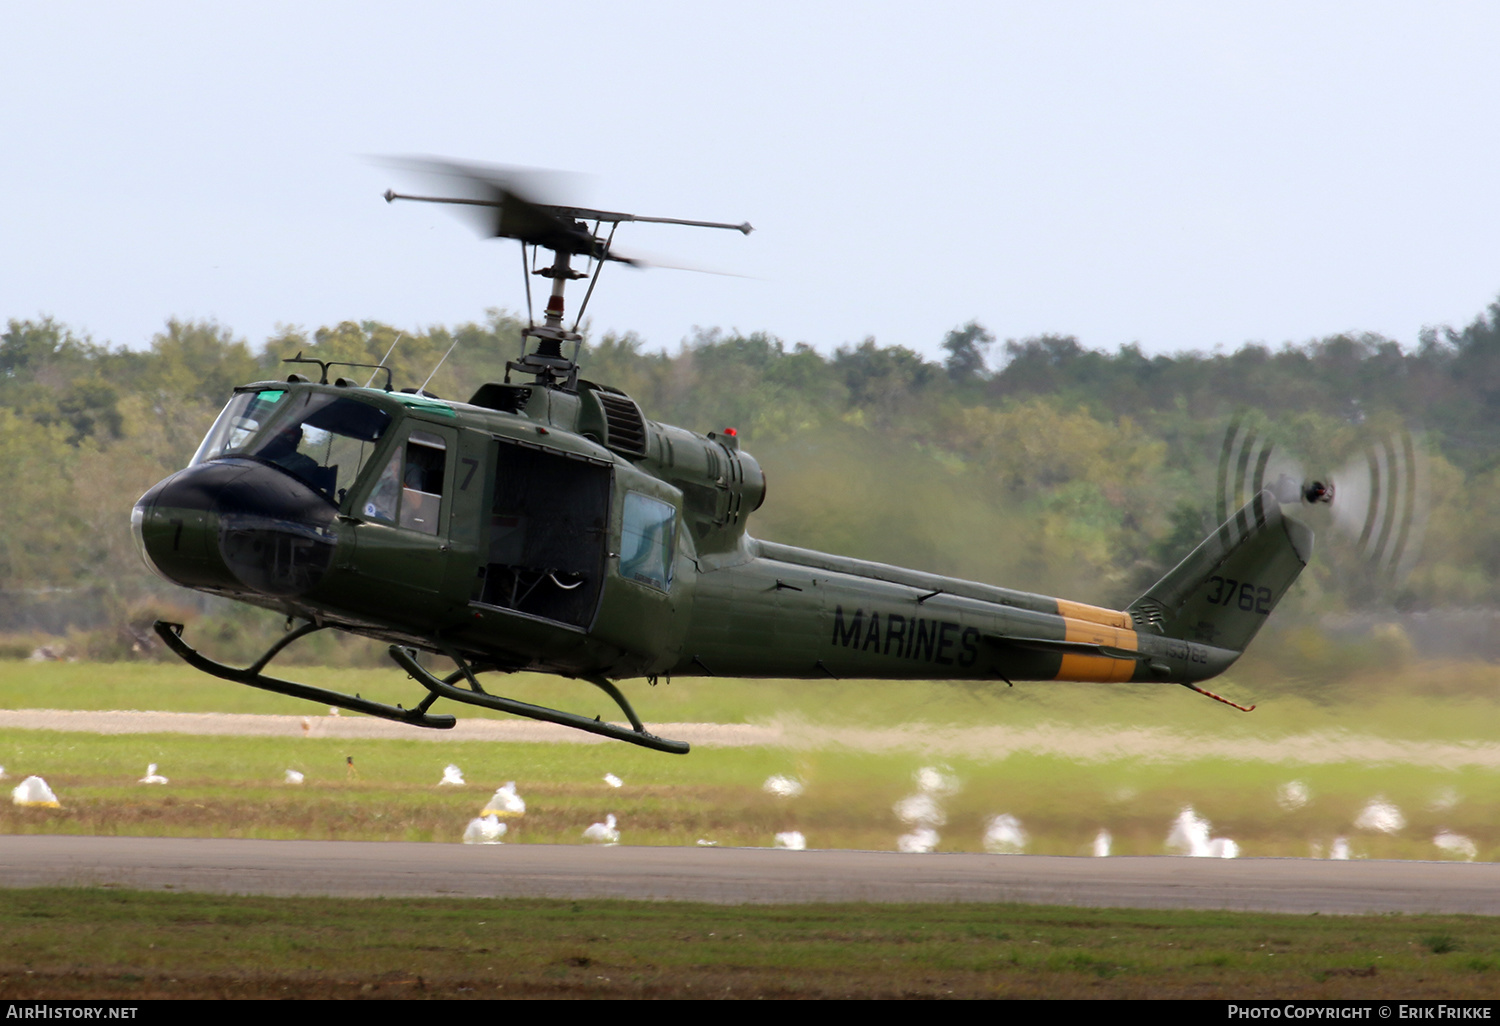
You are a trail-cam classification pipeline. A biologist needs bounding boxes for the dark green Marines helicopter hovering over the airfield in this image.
[131,164,1332,755]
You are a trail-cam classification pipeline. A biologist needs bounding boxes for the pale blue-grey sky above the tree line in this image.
[0,0,1500,364]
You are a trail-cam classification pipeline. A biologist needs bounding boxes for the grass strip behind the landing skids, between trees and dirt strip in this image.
[0,660,1500,743]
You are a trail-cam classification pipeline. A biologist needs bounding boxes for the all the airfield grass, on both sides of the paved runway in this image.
[0,663,1500,1001]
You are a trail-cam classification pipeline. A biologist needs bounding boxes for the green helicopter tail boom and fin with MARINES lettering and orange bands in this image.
[671,492,1313,684]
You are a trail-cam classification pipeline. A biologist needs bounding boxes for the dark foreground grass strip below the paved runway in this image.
[0,890,1500,1001]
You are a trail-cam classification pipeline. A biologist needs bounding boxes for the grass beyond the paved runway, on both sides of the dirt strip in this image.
[0,663,1500,860]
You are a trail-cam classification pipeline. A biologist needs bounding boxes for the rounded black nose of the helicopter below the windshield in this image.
[131,459,338,599]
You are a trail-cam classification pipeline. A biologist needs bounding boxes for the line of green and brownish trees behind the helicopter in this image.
[0,302,1500,654]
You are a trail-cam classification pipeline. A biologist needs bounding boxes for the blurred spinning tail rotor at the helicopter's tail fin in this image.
[1217,419,1427,584]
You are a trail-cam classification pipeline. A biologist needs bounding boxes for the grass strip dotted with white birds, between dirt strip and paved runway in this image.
[0,731,1500,861]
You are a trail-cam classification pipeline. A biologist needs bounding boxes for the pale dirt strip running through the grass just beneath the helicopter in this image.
[0,710,1500,770]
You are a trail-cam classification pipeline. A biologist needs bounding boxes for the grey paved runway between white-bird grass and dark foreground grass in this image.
[0,836,1500,915]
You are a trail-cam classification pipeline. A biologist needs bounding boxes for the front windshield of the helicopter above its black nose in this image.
[194,390,390,506]
